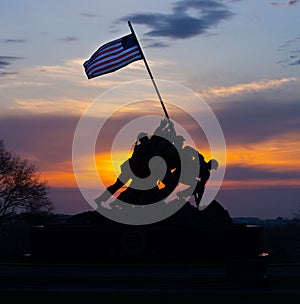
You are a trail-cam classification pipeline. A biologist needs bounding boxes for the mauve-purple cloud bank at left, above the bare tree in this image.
[0,115,79,170]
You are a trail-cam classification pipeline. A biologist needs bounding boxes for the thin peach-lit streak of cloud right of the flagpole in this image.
[199,77,297,97]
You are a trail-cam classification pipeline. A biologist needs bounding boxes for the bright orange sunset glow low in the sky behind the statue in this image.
[41,134,300,189]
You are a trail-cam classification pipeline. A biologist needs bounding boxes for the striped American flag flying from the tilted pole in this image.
[83,34,143,79]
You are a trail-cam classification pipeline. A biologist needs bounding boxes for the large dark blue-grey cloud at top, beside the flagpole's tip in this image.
[119,0,233,47]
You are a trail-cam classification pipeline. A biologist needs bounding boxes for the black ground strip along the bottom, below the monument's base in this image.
[0,263,300,304]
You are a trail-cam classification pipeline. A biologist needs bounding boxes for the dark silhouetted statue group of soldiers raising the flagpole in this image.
[95,118,218,208]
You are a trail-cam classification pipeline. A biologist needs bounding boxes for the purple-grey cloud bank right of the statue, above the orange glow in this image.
[214,97,300,144]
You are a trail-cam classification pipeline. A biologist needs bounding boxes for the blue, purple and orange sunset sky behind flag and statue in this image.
[0,0,300,218]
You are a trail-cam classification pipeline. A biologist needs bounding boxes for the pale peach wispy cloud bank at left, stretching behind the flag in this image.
[0,58,166,117]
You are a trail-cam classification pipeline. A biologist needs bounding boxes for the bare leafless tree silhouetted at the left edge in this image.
[0,140,53,222]
